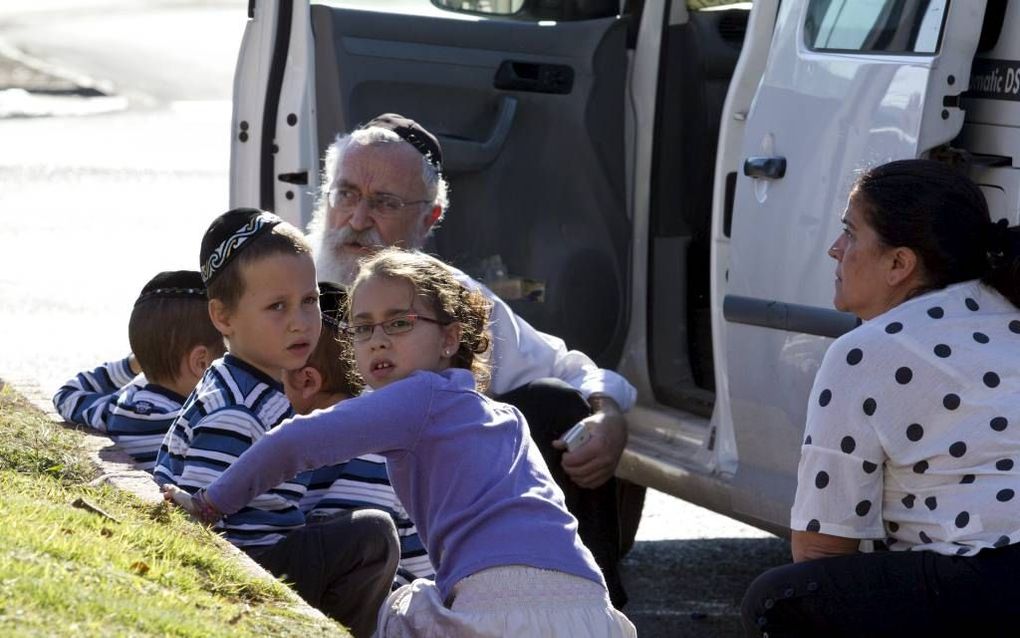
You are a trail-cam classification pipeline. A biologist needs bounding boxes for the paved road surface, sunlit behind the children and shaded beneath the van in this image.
[0,0,788,638]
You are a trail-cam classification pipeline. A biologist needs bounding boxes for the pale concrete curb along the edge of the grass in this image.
[11,381,328,621]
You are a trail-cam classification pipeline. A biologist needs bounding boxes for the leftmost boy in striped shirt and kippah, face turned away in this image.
[53,271,223,473]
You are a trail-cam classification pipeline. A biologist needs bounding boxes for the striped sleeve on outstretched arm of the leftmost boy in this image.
[53,356,136,432]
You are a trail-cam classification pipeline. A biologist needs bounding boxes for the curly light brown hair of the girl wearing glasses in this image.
[343,248,493,392]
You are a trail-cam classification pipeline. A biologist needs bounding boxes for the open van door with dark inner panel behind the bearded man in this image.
[232,0,631,367]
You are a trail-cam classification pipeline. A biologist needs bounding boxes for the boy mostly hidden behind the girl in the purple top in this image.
[284,282,436,589]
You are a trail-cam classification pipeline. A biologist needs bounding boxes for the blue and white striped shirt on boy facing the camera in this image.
[154,353,310,547]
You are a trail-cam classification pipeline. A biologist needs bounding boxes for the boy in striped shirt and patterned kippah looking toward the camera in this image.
[154,208,399,636]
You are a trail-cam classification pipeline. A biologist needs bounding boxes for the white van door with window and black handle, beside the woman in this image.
[714,0,985,527]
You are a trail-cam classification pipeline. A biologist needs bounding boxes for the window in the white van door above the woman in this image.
[804,0,949,54]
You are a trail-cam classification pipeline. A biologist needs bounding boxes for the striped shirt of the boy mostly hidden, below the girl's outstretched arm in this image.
[301,454,436,588]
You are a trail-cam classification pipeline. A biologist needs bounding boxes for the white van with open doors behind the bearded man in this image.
[231,0,1020,533]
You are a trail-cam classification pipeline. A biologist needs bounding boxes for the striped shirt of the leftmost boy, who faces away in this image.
[53,357,185,473]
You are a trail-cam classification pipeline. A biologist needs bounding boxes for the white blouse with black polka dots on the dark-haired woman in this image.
[791,282,1020,555]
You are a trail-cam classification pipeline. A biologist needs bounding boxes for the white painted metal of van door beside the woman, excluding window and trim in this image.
[715,1,983,525]
